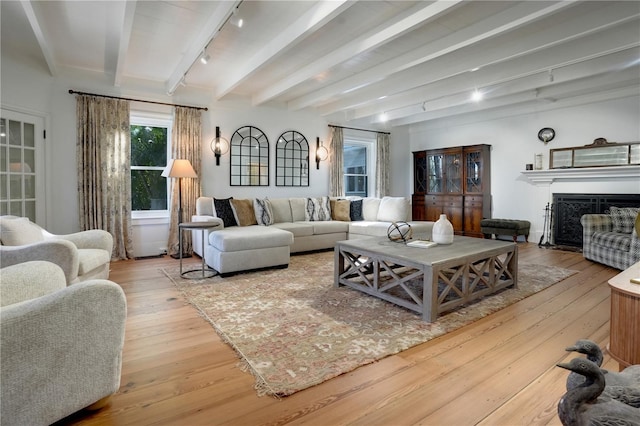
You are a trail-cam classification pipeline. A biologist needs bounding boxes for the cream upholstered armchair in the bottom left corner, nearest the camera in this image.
[0,261,127,425]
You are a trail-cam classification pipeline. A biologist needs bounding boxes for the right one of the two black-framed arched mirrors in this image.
[276,130,309,186]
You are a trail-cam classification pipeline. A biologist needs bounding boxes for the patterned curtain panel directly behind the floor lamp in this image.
[167,107,202,256]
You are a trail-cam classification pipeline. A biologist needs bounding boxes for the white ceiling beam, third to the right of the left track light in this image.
[287,2,572,110]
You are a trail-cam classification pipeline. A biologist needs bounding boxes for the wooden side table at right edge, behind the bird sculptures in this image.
[608,262,640,370]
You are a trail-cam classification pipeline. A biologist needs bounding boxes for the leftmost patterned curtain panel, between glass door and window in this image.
[76,95,133,260]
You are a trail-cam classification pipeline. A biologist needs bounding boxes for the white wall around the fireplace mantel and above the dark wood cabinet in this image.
[404,95,640,241]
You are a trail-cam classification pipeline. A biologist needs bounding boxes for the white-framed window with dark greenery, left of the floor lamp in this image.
[130,116,171,216]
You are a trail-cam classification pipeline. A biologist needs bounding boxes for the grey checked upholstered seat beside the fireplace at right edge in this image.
[580,207,640,270]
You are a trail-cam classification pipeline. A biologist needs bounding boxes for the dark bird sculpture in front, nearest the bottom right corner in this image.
[557,358,640,426]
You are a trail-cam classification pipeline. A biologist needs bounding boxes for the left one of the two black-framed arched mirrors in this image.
[230,126,269,186]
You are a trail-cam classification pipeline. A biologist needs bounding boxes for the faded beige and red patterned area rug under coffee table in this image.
[164,252,576,397]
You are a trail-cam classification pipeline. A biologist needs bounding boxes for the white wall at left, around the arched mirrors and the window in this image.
[0,54,330,256]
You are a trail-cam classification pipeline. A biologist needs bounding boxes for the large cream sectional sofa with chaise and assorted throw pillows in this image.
[192,197,433,275]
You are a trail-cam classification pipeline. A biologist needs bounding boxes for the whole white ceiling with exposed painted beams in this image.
[1,0,640,127]
